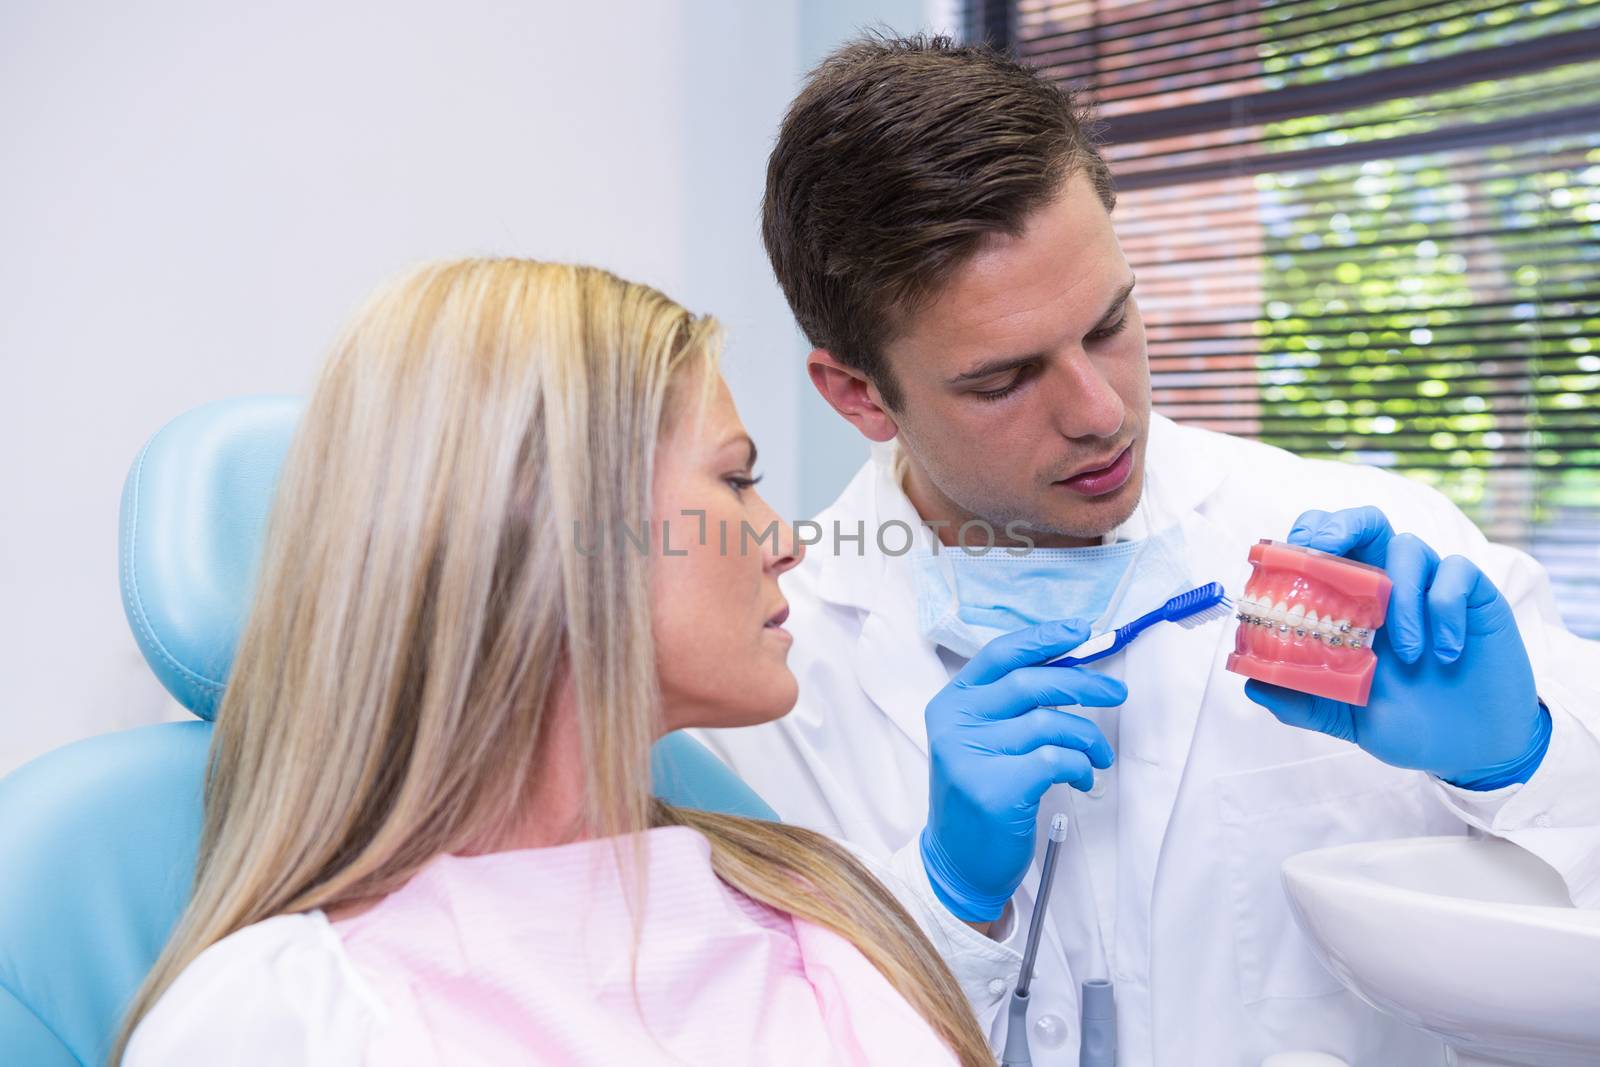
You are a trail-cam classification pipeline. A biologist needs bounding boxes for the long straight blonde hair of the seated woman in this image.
[110,259,994,1065]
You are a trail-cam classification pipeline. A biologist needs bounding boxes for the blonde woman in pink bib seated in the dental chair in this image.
[112,259,994,1067]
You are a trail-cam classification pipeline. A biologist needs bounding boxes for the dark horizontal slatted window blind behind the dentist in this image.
[968,0,1600,637]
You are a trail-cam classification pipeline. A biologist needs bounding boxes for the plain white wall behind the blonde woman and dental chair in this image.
[0,0,949,774]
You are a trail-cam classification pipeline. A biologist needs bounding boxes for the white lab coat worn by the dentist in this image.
[698,416,1600,1067]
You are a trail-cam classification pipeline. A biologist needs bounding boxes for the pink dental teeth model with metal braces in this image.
[1227,539,1392,707]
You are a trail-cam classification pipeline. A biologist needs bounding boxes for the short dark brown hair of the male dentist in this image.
[762,35,1115,408]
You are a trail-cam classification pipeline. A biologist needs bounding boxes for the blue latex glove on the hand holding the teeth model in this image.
[1245,507,1550,789]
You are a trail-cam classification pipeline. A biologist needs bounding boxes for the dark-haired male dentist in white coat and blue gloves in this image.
[701,38,1600,1067]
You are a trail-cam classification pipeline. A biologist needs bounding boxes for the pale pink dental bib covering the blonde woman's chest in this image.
[323,827,954,1067]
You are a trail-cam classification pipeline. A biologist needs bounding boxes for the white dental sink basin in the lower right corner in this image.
[1283,837,1600,1067]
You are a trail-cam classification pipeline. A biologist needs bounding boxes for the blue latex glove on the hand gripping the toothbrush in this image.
[922,621,1128,923]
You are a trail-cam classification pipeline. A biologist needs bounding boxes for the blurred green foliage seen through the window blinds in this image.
[1254,22,1600,629]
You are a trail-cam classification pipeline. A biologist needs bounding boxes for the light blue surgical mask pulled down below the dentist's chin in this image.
[910,499,1190,659]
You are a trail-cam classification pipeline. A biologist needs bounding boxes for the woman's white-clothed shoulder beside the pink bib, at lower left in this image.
[123,912,386,1067]
